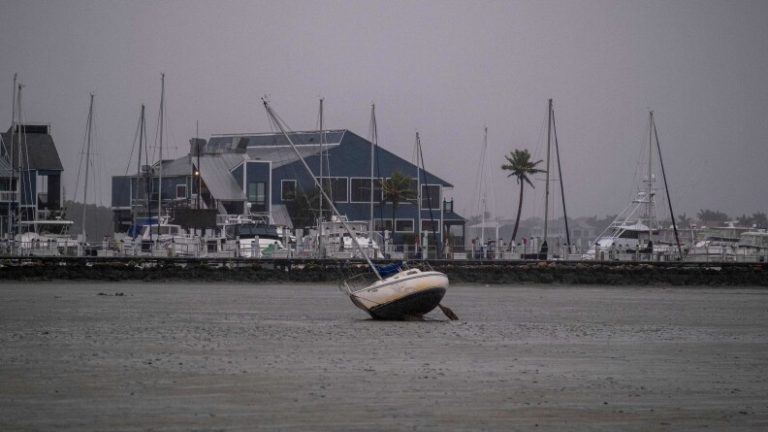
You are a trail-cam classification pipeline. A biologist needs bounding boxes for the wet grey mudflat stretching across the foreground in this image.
[0,283,768,431]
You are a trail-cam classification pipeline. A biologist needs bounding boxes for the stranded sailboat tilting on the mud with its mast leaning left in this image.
[262,98,457,320]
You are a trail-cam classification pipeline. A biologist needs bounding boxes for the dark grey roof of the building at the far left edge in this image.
[2,125,64,171]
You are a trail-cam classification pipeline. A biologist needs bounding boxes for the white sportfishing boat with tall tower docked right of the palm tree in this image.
[582,111,682,260]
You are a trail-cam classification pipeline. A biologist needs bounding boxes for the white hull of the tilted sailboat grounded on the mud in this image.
[350,269,448,320]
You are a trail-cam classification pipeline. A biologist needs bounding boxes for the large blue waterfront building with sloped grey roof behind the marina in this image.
[112,126,465,251]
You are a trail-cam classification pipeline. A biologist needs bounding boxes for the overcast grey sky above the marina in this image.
[0,0,768,221]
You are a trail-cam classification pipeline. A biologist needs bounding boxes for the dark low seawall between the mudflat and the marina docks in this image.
[0,257,768,287]
